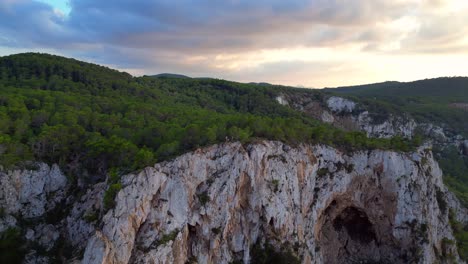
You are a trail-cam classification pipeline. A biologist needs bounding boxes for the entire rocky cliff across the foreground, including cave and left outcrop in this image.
[0,141,468,263]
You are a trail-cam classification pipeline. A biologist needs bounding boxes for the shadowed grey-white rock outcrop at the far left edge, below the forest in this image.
[0,163,69,263]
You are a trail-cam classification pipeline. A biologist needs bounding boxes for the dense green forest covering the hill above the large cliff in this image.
[0,53,420,185]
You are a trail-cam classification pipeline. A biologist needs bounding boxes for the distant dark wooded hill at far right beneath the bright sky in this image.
[324,77,468,136]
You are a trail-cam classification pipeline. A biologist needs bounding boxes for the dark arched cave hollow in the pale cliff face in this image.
[317,201,407,264]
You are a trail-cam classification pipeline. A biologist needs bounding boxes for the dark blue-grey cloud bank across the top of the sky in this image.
[0,0,416,50]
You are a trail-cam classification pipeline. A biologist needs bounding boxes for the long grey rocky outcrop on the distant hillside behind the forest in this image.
[277,93,468,144]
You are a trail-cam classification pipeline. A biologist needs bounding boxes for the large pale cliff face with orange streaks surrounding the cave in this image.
[83,142,466,263]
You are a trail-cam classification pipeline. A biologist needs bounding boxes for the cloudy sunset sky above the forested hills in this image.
[0,0,468,88]
